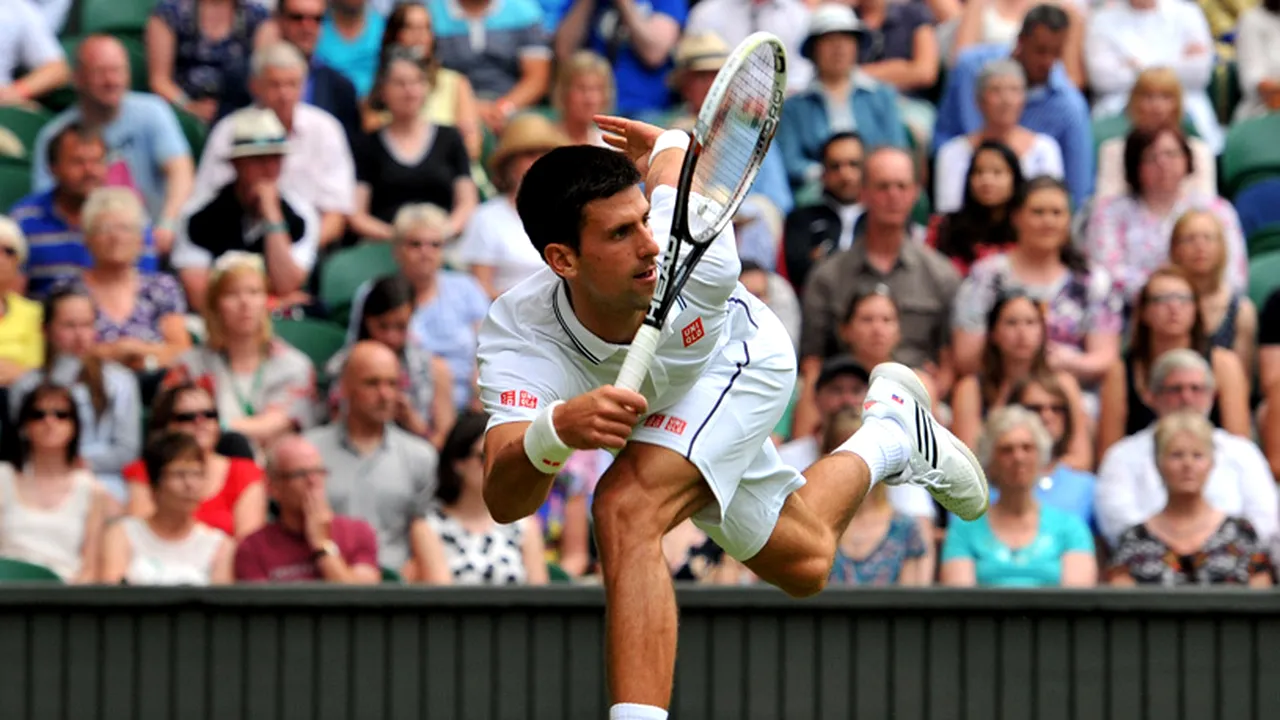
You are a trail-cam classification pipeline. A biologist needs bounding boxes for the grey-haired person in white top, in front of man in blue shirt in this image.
[933,59,1064,213]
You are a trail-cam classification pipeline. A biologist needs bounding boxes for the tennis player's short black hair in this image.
[516,145,641,255]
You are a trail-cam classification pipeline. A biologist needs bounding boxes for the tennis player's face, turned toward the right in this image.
[565,187,658,310]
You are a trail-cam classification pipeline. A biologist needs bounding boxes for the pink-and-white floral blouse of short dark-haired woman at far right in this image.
[1084,192,1249,301]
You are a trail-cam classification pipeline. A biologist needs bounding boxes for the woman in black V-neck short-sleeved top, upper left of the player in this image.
[351,49,479,240]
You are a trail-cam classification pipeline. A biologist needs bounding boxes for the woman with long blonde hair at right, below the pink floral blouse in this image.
[1169,210,1258,378]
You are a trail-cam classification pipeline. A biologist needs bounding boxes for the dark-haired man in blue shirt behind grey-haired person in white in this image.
[933,5,1093,206]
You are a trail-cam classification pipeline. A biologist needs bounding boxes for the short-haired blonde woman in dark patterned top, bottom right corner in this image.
[1106,411,1271,588]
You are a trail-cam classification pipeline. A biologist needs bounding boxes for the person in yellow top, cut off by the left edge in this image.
[0,215,45,387]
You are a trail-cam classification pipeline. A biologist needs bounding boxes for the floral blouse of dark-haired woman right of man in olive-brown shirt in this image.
[954,254,1124,350]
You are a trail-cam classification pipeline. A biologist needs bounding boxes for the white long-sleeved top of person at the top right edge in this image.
[1084,0,1224,152]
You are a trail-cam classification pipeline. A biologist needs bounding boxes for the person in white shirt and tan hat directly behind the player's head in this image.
[457,113,570,299]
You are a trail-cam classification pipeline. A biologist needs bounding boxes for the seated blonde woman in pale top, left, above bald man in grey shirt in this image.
[164,251,315,448]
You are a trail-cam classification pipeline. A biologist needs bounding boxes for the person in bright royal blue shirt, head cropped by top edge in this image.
[556,0,689,118]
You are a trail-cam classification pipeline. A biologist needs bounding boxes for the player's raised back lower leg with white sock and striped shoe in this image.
[745,363,988,597]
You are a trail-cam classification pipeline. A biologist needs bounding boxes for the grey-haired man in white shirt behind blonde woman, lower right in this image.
[1094,350,1280,547]
